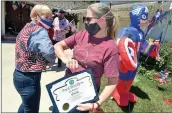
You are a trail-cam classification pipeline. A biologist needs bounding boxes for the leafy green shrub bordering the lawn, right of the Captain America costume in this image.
[138,42,172,82]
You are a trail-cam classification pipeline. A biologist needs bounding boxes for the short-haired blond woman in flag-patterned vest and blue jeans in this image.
[13,5,55,113]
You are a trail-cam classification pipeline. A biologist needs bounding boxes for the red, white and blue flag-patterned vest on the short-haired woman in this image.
[15,22,46,71]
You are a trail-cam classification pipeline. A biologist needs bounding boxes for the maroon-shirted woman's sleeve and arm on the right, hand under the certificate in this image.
[77,54,119,111]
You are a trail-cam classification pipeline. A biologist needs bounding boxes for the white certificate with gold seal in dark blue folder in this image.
[46,69,99,113]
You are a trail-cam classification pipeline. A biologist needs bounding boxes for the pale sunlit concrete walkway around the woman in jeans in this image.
[2,42,71,112]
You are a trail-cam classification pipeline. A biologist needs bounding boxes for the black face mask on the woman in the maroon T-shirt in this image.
[85,23,101,36]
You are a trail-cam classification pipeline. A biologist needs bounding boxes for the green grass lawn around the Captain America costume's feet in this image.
[101,75,172,112]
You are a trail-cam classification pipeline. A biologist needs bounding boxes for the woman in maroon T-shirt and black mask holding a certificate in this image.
[55,3,119,111]
